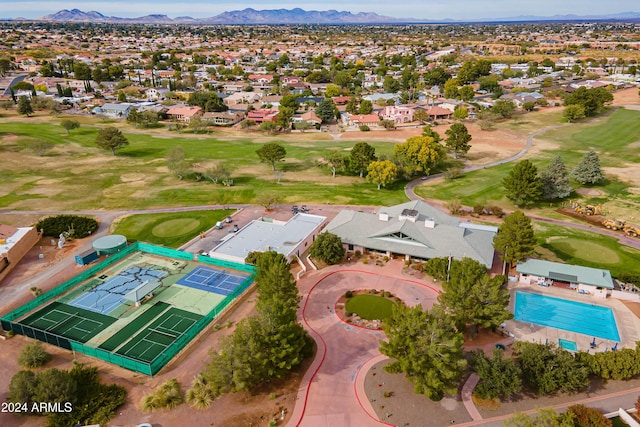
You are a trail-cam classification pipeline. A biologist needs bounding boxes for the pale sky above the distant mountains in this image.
[0,0,640,20]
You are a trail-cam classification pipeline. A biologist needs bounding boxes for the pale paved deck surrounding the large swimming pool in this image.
[505,282,640,352]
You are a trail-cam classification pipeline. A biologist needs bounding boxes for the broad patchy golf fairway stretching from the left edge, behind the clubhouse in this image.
[0,122,407,209]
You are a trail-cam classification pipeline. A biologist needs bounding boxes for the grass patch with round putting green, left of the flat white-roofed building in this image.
[112,209,235,248]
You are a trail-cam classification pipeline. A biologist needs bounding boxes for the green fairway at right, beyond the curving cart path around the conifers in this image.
[416,109,640,209]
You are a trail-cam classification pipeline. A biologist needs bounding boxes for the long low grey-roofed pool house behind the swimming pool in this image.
[516,259,614,299]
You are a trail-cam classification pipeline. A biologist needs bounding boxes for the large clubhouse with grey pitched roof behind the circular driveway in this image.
[327,200,498,268]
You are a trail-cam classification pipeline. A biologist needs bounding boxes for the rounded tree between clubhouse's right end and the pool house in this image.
[493,211,537,265]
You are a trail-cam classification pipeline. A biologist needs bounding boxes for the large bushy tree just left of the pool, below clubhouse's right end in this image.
[438,258,513,334]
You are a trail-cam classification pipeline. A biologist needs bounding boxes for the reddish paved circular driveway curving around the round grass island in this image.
[288,260,438,427]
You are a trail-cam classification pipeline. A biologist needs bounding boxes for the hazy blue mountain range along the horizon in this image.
[7,8,640,25]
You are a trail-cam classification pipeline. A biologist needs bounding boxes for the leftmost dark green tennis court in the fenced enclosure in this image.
[21,302,116,343]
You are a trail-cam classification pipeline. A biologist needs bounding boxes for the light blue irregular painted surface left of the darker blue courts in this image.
[69,267,167,314]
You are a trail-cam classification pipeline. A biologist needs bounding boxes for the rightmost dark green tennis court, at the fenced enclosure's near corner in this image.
[116,308,202,362]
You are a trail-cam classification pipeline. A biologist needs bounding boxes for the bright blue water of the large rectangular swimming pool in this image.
[514,292,620,342]
